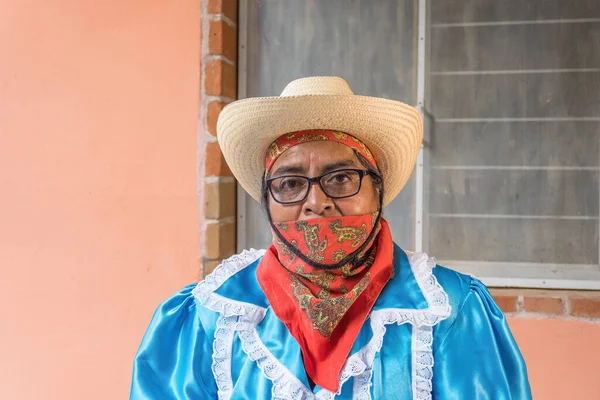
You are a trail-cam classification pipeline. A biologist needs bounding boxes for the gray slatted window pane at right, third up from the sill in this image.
[429,121,600,168]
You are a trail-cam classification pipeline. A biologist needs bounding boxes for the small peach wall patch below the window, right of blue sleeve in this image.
[509,318,600,400]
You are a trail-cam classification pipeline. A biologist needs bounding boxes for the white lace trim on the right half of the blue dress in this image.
[317,252,451,400]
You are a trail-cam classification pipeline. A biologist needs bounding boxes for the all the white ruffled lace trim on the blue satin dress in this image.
[193,250,451,400]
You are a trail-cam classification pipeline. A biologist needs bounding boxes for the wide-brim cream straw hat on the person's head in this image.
[217,77,423,205]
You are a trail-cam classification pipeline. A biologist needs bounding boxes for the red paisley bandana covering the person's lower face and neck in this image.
[257,216,393,392]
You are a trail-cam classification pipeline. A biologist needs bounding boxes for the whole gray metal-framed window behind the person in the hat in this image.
[238,0,600,289]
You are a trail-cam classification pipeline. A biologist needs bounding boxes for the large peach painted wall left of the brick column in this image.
[0,0,200,400]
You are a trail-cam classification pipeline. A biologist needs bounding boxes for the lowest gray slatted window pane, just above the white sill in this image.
[429,218,598,264]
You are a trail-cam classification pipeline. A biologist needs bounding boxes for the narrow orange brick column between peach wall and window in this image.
[199,0,238,276]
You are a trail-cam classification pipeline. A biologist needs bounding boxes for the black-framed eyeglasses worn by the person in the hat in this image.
[266,169,370,204]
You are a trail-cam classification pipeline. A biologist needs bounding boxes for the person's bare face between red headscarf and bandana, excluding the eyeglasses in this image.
[268,141,379,222]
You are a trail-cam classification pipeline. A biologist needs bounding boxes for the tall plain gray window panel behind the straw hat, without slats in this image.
[241,0,416,248]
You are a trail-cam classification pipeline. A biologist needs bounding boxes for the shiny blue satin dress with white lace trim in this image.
[130,247,531,400]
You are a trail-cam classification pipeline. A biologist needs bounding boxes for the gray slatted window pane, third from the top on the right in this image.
[431,72,600,119]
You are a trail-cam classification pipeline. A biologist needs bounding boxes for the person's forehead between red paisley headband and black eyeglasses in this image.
[271,141,360,172]
